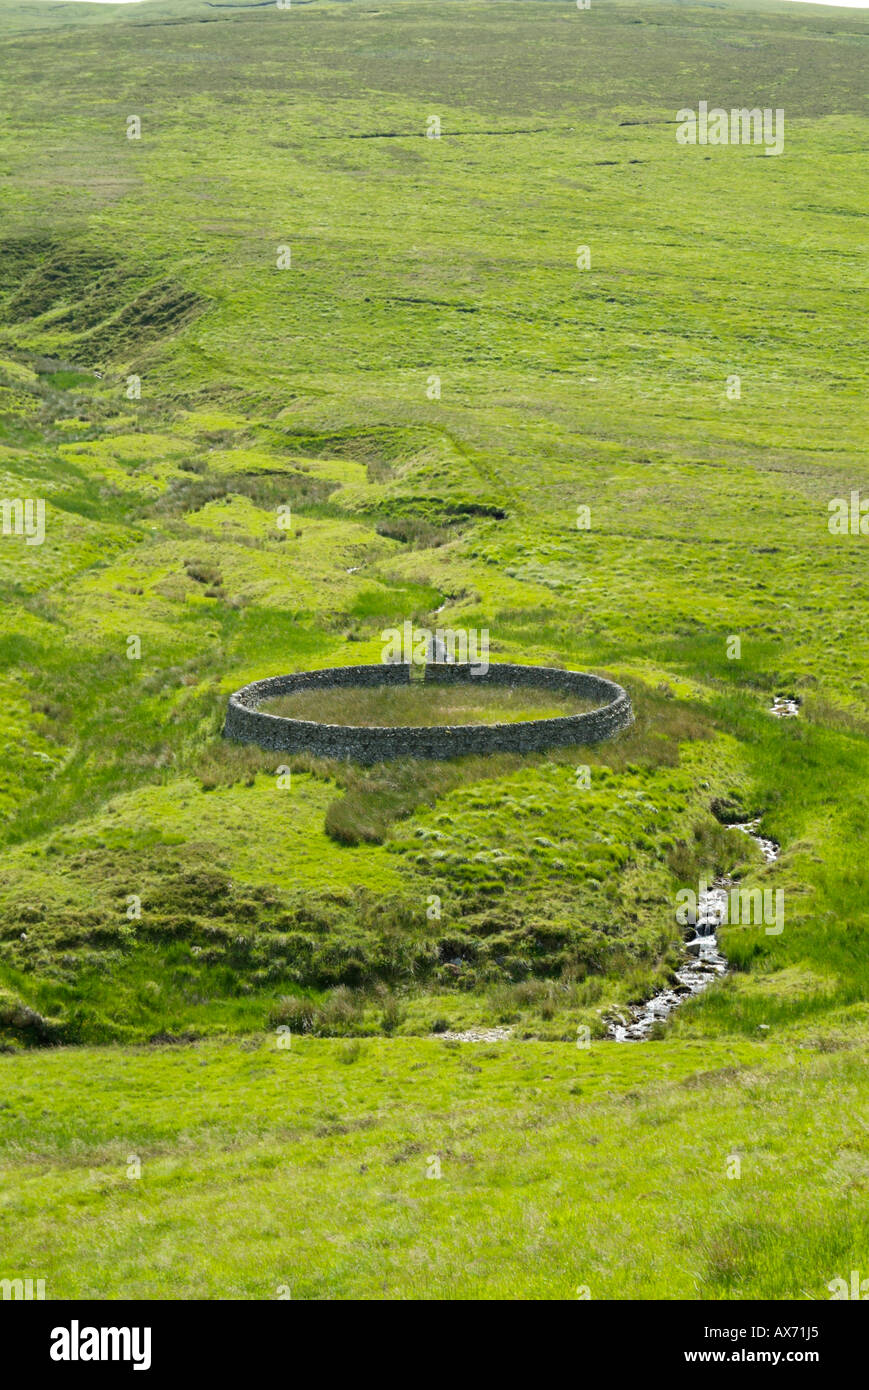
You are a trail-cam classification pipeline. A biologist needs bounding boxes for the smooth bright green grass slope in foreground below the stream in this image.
[0,1037,869,1300]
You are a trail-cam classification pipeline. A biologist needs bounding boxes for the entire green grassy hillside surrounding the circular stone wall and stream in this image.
[0,0,869,1298]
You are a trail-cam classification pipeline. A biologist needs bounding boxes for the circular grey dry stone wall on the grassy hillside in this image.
[224,662,634,763]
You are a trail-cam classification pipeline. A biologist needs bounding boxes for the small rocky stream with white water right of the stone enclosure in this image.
[608,695,799,1043]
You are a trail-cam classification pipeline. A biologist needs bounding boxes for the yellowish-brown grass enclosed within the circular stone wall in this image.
[259,682,596,728]
